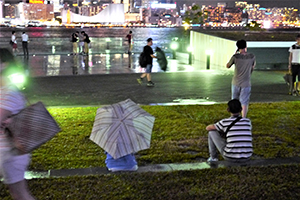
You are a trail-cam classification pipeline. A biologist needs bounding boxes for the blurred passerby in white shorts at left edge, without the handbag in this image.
[0,49,34,200]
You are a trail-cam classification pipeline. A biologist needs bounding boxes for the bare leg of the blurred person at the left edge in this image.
[7,179,35,200]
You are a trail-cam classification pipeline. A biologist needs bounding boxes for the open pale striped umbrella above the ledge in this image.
[90,99,155,159]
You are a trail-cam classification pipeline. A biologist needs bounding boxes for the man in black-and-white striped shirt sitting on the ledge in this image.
[206,99,253,163]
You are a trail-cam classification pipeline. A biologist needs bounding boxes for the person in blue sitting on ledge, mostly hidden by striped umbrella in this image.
[105,152,138,172]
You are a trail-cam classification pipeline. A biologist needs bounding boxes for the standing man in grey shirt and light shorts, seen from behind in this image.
[226,40,256,117]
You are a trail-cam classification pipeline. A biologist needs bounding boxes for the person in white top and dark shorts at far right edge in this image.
[288,34,300,96]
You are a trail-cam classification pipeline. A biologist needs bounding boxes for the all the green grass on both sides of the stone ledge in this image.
[0,102,300,200]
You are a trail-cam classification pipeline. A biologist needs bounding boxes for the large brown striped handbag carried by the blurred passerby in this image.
[5,102,61,154]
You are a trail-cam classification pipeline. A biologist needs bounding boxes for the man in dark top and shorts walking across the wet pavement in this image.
[137,38,156,87]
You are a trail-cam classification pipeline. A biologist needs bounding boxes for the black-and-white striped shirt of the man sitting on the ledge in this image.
[215,117,253,159]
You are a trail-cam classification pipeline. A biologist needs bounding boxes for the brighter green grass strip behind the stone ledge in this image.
[29,102,300,170]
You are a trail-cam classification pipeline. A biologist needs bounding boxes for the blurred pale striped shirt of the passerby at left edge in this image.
[0,86,26,150]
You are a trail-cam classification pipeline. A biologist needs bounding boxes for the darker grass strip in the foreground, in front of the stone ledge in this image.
[0,165,300,200]
